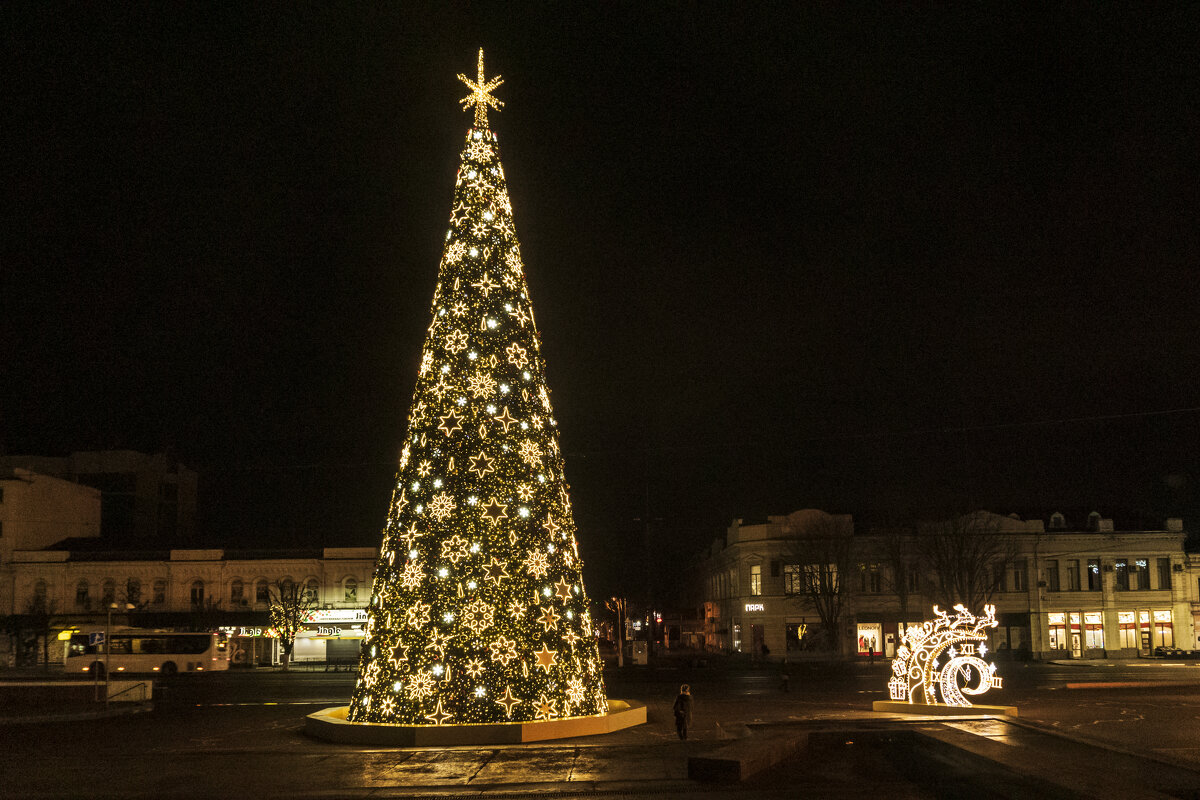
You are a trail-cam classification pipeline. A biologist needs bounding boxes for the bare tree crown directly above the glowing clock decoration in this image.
[918,511,1016,612]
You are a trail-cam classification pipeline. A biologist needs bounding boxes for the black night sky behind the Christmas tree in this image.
[0,2,1200,594]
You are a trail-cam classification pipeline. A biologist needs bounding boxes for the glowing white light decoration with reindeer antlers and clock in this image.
[888,603,1002,708]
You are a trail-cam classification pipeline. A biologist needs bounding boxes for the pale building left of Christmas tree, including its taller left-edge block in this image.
[0,459,377,666]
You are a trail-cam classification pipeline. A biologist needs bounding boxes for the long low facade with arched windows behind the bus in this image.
[0,541,377,664]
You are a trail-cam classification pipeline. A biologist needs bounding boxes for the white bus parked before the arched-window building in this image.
[64,628,230,678]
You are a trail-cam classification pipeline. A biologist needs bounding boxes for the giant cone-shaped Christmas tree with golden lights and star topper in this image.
[348,50,607,726]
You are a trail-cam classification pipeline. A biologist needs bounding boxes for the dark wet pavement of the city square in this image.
[0,662,1200,798]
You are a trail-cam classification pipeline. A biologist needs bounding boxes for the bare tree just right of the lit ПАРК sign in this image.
[784,509,854,650]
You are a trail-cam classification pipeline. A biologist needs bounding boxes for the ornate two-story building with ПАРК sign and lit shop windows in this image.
[697,510,1200,658]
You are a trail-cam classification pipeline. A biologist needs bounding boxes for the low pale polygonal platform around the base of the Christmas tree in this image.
[305,700,646,747]
